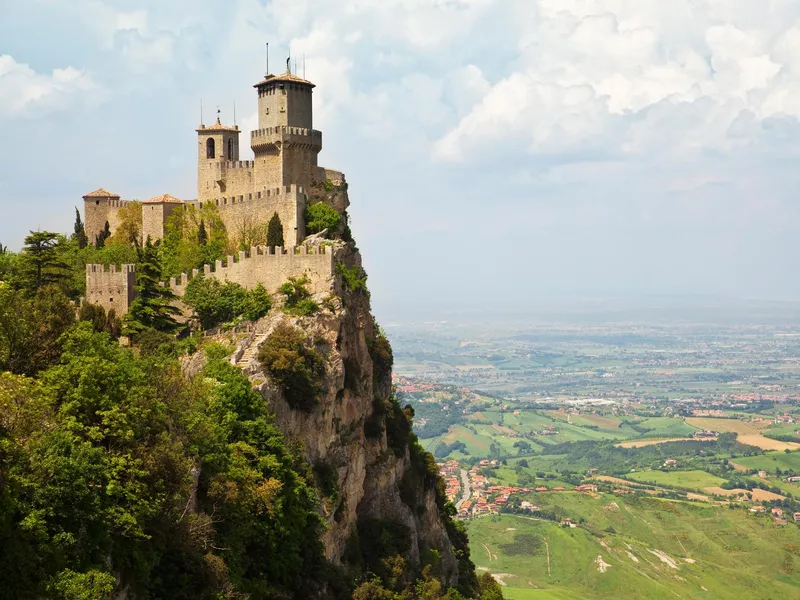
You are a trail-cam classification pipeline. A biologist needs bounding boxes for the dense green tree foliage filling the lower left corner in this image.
[0,322,324,600]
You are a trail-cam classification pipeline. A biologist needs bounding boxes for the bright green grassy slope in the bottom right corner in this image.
[467,494,800,600]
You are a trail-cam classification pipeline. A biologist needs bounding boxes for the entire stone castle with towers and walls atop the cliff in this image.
[83,66,347,314]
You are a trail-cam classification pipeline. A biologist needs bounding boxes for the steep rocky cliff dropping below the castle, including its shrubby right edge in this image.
[228,240,474,589]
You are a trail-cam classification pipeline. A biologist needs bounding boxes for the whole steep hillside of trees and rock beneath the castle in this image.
[0,205,494,600]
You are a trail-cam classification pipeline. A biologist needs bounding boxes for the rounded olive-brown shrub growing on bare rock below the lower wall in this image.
[258,323,325,411]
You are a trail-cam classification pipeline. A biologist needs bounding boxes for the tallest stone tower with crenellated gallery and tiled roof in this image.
[251,71,322,190]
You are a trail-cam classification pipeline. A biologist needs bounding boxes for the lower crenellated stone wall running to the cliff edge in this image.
[168,246,334,296]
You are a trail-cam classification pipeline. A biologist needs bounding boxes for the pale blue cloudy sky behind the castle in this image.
[0,0,800,318]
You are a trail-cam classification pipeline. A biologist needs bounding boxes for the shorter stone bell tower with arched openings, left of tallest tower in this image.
[197,116,241,198]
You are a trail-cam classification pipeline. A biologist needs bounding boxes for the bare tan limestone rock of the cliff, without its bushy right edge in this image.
[234,242,458,584]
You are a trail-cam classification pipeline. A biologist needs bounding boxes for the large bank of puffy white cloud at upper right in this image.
[433,0,800,162]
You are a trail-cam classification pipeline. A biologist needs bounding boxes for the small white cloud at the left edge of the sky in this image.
[0,54,102,117]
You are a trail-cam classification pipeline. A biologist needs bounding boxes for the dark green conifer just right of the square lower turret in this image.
[123,238,181,335]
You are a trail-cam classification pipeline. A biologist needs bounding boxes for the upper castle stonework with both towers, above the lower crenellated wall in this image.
[83,67,344,245]
